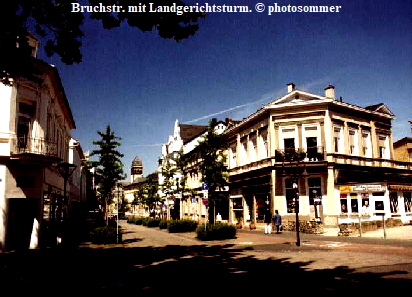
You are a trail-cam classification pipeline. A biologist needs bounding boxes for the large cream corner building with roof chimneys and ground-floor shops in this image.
[225,83,412,226]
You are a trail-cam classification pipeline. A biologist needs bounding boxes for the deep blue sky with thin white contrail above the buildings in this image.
[40,0,412,180]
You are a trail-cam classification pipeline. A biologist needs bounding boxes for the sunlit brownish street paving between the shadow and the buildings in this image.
[122,223,412,268]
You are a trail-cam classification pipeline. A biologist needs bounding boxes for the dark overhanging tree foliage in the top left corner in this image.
[0,0,205,85]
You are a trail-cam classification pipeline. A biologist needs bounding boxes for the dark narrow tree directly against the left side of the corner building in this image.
[192,119,228,223]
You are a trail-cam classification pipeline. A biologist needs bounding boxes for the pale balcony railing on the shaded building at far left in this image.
[12,136,58,157]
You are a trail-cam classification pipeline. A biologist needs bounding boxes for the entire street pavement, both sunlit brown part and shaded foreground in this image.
[0,222,412,296]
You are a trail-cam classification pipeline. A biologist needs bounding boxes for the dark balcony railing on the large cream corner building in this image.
[275,146,325,162]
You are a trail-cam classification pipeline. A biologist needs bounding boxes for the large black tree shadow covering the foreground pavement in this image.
[0,245,411,296]
